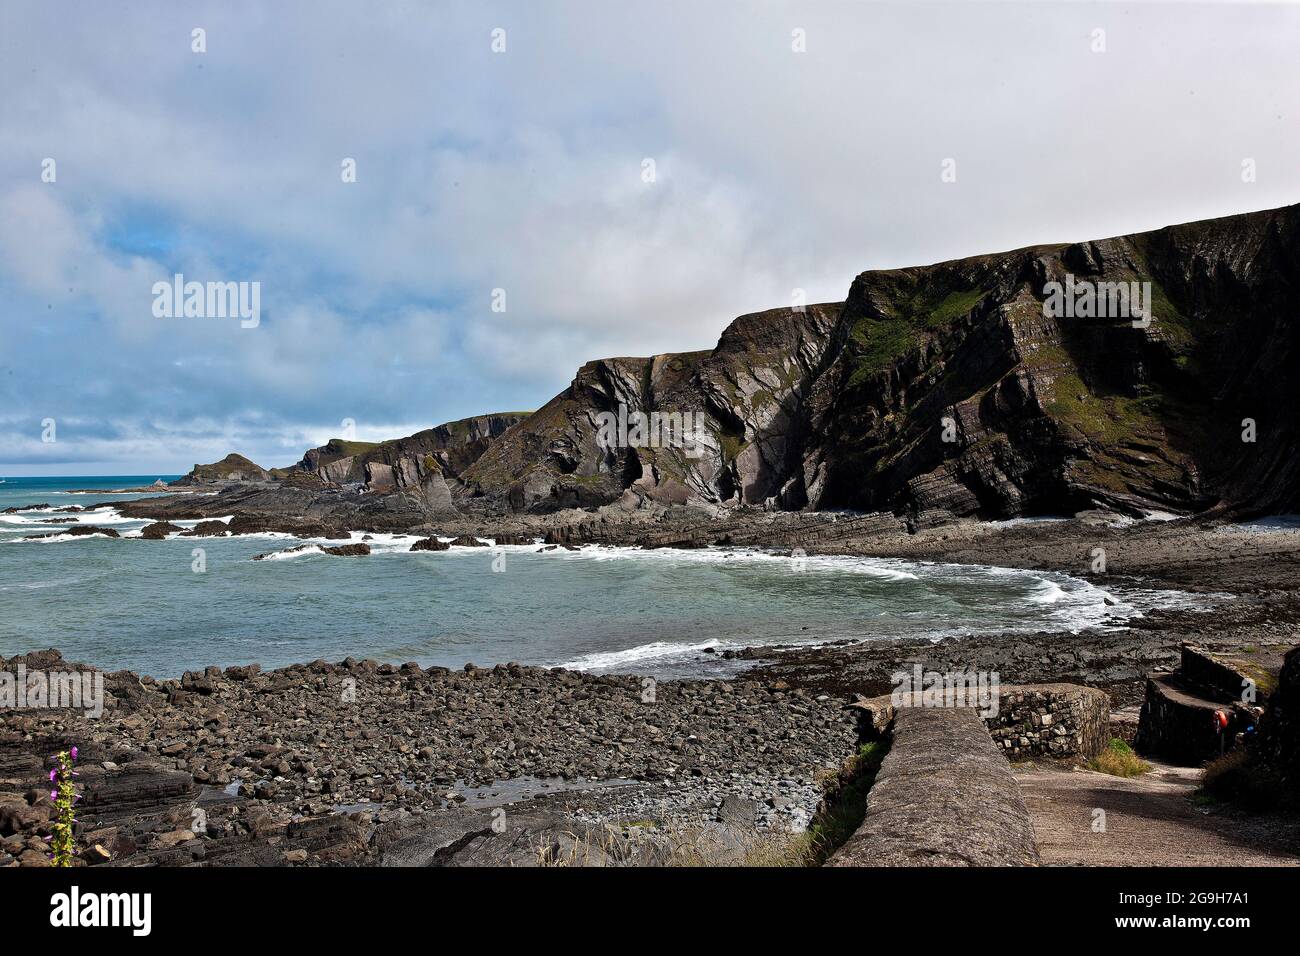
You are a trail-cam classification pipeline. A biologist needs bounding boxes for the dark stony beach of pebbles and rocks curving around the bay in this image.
[0,509,1300,865]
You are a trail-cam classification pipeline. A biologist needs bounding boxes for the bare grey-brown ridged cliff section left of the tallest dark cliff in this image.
[462,303,840,510]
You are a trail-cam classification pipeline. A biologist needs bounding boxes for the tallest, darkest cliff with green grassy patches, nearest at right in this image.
[803,207,1300,516]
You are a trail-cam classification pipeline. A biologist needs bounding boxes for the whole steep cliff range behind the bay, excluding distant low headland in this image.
[456,200,1300,518]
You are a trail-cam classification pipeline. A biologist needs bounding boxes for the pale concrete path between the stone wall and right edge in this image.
[1015,761,1300,866]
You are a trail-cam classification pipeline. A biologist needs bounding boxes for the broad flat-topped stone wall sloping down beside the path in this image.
[828,708,1039,866]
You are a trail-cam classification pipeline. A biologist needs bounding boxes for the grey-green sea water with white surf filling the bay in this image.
[0,475,1186,678]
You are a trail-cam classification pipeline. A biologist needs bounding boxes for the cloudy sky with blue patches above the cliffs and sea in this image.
[0,0,1300,476]
